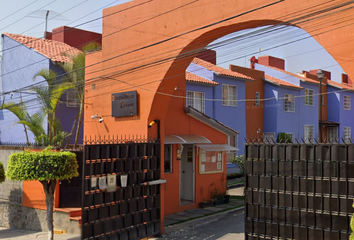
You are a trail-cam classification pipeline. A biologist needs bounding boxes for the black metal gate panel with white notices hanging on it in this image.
[81,141,160,240]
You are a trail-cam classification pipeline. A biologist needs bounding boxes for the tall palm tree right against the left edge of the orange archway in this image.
[61,42,101,146]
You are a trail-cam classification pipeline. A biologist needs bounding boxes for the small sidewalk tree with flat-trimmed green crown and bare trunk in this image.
[5,147,79,240]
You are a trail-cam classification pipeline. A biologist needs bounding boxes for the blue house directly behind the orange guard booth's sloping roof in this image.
[186,55,253,159]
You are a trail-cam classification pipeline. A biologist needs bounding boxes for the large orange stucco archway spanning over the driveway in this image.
[85,0,354,137]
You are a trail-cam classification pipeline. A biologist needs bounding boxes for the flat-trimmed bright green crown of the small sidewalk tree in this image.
[6,150,79,181]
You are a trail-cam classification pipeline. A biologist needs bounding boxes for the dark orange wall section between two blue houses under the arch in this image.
[230,65,265,141]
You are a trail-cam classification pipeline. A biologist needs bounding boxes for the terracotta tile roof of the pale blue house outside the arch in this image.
[3,33,81,62]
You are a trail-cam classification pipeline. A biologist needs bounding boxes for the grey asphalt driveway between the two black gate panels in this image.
[153,213,245,240]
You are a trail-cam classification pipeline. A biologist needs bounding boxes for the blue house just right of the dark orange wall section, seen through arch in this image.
[253,56,319,142]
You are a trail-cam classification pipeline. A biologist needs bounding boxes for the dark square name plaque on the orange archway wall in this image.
[112,91,138,117]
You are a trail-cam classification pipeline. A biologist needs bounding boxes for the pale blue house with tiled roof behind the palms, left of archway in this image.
[0,33,83,144]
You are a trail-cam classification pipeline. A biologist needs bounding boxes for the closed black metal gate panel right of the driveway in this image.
[245,143,354,240]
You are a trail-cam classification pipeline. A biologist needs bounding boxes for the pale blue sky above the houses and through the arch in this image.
[0,0,343,81]
